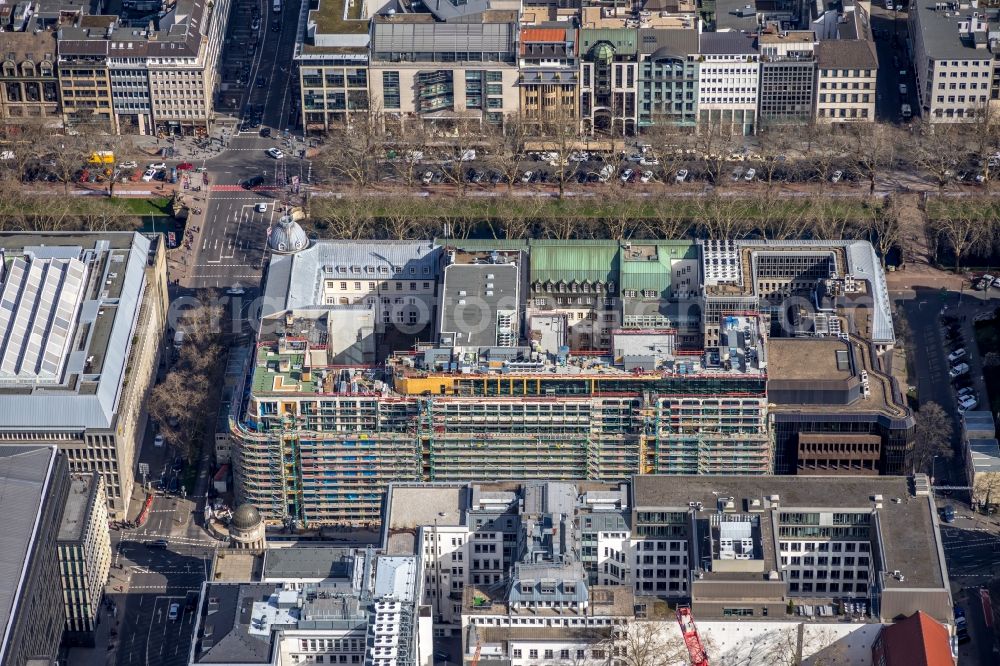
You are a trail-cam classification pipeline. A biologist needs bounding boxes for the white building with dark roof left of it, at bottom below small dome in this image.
[188,551,433,666]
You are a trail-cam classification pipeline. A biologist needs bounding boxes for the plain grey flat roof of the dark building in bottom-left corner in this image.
[0,446,58,663]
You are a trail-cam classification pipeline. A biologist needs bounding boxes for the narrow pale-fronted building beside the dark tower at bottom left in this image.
[57,473,111,647]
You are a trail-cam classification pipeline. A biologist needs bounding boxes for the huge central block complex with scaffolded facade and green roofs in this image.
[229,239,913,526]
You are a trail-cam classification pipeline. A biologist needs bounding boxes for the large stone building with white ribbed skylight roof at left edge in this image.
[0,232,168,519]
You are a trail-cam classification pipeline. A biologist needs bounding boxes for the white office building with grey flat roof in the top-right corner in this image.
[907,2,1000,123]
